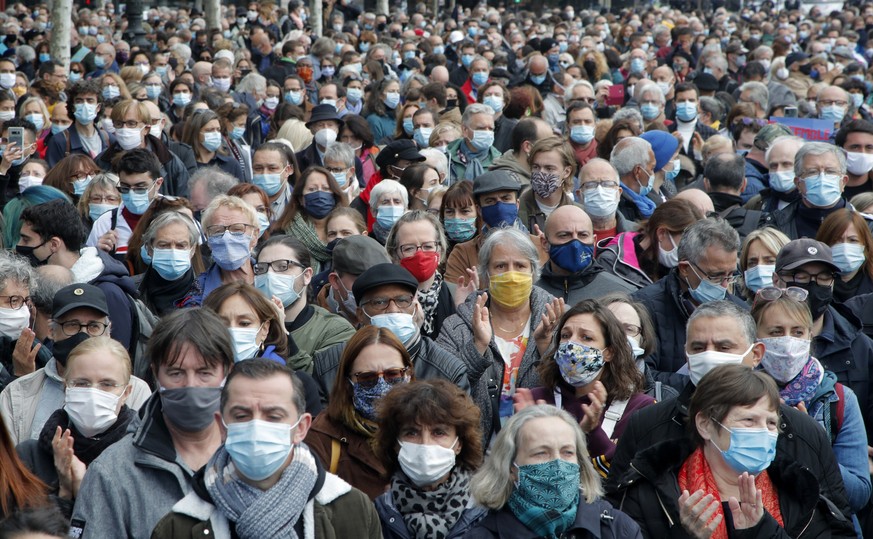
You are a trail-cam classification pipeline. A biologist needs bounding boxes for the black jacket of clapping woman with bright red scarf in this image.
[610,435,855,539]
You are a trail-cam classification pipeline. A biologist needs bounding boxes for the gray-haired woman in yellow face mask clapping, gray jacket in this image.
[437,228,564,444]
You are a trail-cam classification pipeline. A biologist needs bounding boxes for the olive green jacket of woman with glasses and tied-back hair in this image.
[285,304,355,374]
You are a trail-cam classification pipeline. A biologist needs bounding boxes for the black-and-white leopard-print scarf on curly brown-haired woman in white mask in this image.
[391,467,470,539]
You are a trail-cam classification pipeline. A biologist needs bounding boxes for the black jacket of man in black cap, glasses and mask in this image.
[312,334,470,406]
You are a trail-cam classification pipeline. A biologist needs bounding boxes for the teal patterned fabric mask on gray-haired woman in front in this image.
[509,459,581,537]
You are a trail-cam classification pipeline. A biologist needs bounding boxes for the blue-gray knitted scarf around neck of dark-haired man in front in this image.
[203,444,318,539]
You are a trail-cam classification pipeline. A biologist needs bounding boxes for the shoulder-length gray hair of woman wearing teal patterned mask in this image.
[470,404,603,511]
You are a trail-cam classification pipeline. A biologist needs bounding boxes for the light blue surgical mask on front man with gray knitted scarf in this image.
[224,419,300,481]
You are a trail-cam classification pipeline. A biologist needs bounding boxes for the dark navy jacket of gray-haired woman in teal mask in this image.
[464,500,642,539]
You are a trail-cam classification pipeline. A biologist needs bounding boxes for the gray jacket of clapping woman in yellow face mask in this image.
[437,286,554,445]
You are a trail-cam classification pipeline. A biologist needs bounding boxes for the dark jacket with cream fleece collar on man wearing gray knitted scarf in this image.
[151,448,382,539]
